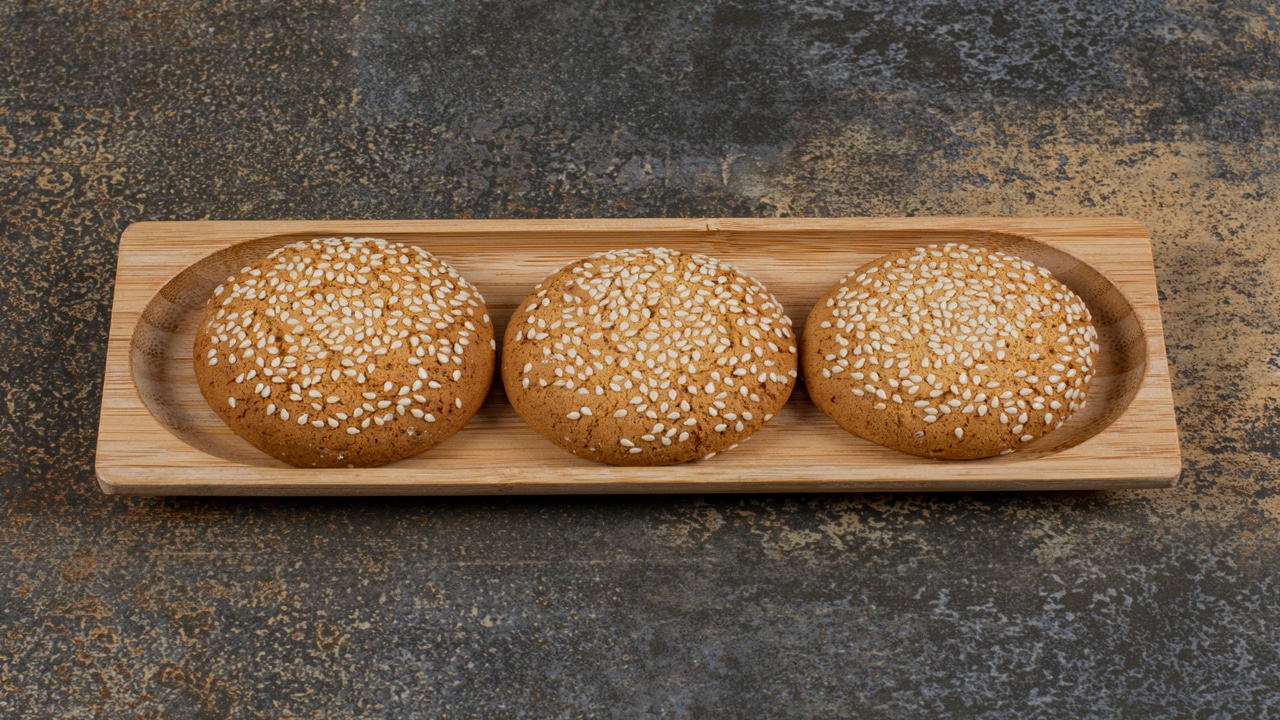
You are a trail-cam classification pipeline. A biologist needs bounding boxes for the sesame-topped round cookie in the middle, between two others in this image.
[502,249,796,465]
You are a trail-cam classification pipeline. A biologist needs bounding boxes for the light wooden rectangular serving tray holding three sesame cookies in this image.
[97,218,1181,495]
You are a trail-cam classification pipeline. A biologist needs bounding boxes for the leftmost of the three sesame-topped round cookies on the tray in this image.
[195,237,494,468]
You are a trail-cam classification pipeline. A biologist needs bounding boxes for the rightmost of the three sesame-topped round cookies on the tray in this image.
[801,243,1098,460]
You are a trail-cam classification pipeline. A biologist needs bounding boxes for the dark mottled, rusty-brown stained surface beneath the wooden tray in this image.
[0,0,1280,719]
